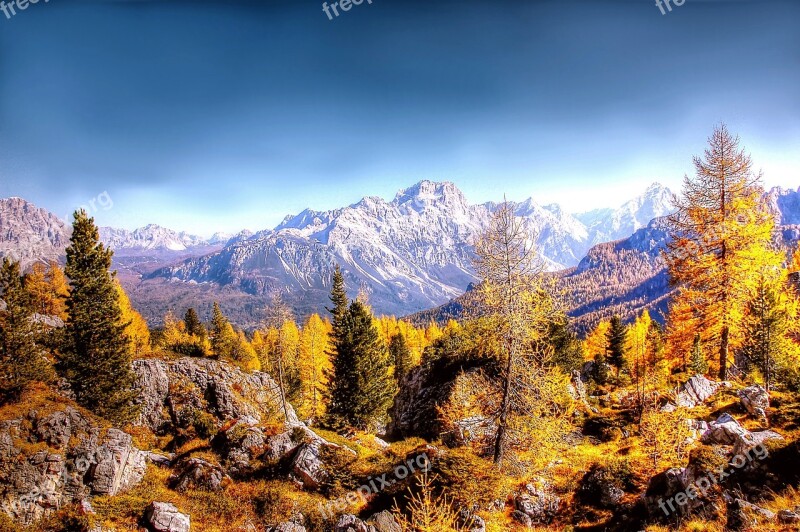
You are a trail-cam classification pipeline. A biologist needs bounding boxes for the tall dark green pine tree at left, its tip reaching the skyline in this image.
[63,210,137,422]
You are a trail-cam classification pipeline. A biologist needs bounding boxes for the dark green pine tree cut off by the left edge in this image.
[0,258,52,403]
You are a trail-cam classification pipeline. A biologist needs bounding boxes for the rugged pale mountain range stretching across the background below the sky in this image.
[0,181,800,327]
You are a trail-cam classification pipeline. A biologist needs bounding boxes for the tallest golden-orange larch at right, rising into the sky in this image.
[666,125,782,380]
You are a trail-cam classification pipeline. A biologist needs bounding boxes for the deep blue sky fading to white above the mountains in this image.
[0,0,800,234]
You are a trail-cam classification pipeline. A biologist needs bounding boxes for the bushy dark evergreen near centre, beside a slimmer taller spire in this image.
[327,301,396,429]
